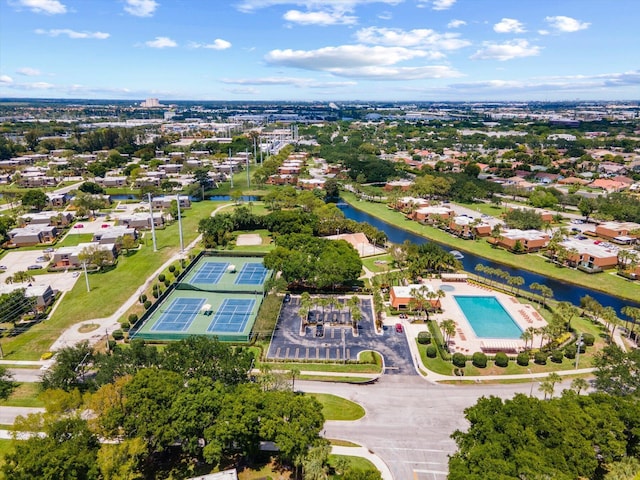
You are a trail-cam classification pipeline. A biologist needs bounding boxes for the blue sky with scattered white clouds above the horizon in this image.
[0,0,640,101]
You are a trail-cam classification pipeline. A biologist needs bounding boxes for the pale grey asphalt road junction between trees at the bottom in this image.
[296,375,556,480]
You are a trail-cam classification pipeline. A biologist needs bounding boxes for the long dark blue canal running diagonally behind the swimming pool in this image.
[338,202,640,318]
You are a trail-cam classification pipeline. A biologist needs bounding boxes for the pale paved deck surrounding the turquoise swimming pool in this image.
[404,280,547,355]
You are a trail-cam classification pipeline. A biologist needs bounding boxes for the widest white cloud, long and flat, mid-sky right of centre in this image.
[265,45,460,80]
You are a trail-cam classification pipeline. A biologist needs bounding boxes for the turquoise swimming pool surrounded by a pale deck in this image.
[453,295,522,339]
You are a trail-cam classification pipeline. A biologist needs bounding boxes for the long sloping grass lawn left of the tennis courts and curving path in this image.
[2,202,219,360]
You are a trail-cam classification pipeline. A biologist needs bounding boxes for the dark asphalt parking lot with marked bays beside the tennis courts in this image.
[267,296,415,375]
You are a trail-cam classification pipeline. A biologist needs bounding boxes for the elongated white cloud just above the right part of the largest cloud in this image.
[356,27,471,52]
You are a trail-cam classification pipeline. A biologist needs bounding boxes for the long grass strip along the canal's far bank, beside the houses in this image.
[341,192,640,301]
